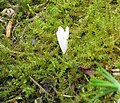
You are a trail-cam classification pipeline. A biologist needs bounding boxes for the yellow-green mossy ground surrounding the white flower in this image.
[0,0,120,103]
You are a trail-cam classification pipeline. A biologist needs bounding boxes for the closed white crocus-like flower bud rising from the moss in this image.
[56,26,69,54]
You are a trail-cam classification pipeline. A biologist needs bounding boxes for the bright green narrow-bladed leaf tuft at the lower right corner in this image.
[87,63,120,103]
